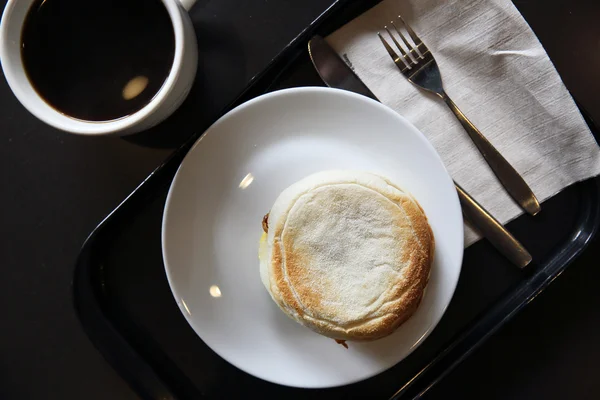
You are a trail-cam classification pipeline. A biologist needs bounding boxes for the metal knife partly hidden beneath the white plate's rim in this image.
[308,36,531,268]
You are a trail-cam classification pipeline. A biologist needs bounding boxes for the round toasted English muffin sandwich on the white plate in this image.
[259,171,434,341]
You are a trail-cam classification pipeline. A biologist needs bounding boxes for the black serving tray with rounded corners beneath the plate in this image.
[73,0,600,400]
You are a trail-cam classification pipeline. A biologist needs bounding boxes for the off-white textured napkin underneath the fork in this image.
[327,0,600,246]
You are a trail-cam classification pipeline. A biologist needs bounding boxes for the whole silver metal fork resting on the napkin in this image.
[377,15,541,215]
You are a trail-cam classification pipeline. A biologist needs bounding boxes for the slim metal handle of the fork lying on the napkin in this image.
[439,91,541,215]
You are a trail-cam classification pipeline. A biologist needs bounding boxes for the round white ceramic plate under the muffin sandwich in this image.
[162,88,463,388]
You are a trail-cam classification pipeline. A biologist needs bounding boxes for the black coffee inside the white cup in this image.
[21,0,175,121]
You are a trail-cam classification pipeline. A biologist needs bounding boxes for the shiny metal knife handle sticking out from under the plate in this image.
[455,182,531,268]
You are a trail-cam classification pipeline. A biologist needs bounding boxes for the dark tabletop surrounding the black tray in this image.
[0,0,600,399]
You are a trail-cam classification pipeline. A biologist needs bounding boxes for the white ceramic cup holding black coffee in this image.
[0,0,198,135]
